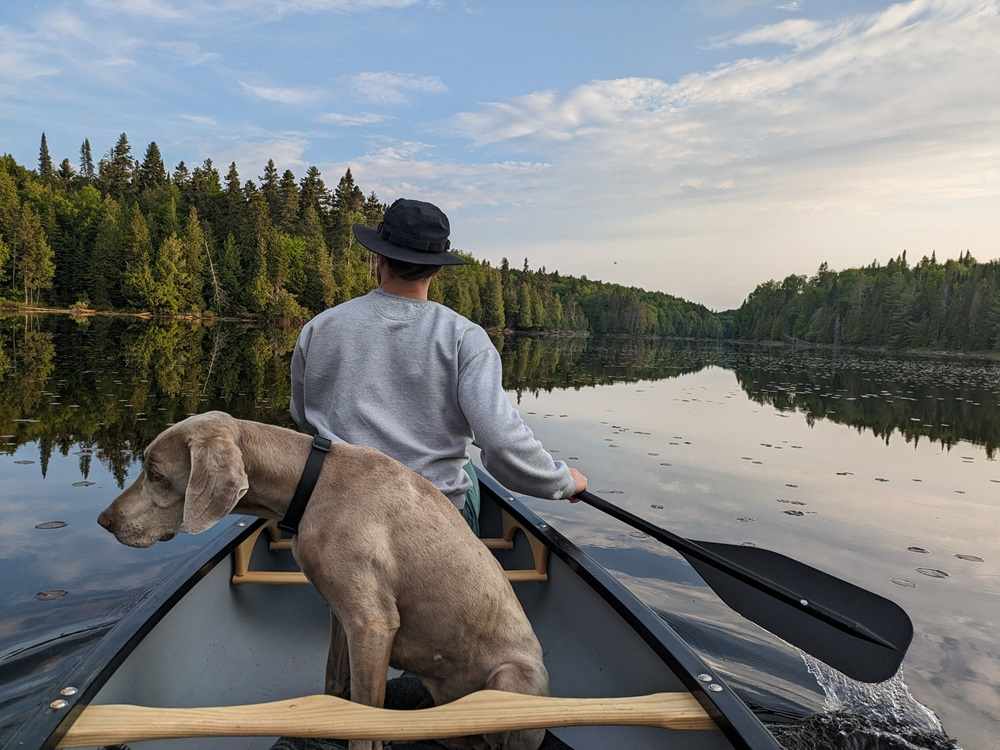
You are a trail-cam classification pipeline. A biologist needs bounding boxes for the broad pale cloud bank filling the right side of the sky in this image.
[448,0,1000,307]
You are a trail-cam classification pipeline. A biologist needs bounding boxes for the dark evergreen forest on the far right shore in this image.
[720,251,1000,351]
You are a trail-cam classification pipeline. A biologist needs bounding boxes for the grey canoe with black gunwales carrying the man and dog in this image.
[15,470,780,750]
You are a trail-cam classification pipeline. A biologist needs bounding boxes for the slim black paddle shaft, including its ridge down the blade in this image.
[577,491,895,649]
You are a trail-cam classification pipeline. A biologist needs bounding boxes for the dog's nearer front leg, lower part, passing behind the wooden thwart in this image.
[345,615,399,750]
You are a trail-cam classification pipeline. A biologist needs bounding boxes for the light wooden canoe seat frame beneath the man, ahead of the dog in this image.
[232,511,549,585]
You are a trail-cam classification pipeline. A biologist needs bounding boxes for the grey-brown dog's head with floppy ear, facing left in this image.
[97,411,250,547]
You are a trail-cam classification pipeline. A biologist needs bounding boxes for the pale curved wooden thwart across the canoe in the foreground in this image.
[57,690,716,748]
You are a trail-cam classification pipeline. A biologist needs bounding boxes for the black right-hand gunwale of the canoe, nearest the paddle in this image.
[477,476,781,750]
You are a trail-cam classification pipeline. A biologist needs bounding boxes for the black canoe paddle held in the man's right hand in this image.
[577,492,913,682]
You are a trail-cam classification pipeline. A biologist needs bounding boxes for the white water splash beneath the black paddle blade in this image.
[771,654,961,750]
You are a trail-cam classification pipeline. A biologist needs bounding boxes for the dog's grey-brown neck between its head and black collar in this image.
[233,420,312,519]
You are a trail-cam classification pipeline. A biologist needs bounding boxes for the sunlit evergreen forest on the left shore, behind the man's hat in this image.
[0,133,722,338]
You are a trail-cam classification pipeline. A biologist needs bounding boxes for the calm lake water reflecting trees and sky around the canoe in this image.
[0,317,1000,748]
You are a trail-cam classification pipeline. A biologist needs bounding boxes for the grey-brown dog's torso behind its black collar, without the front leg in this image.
[295,445,548,748]
